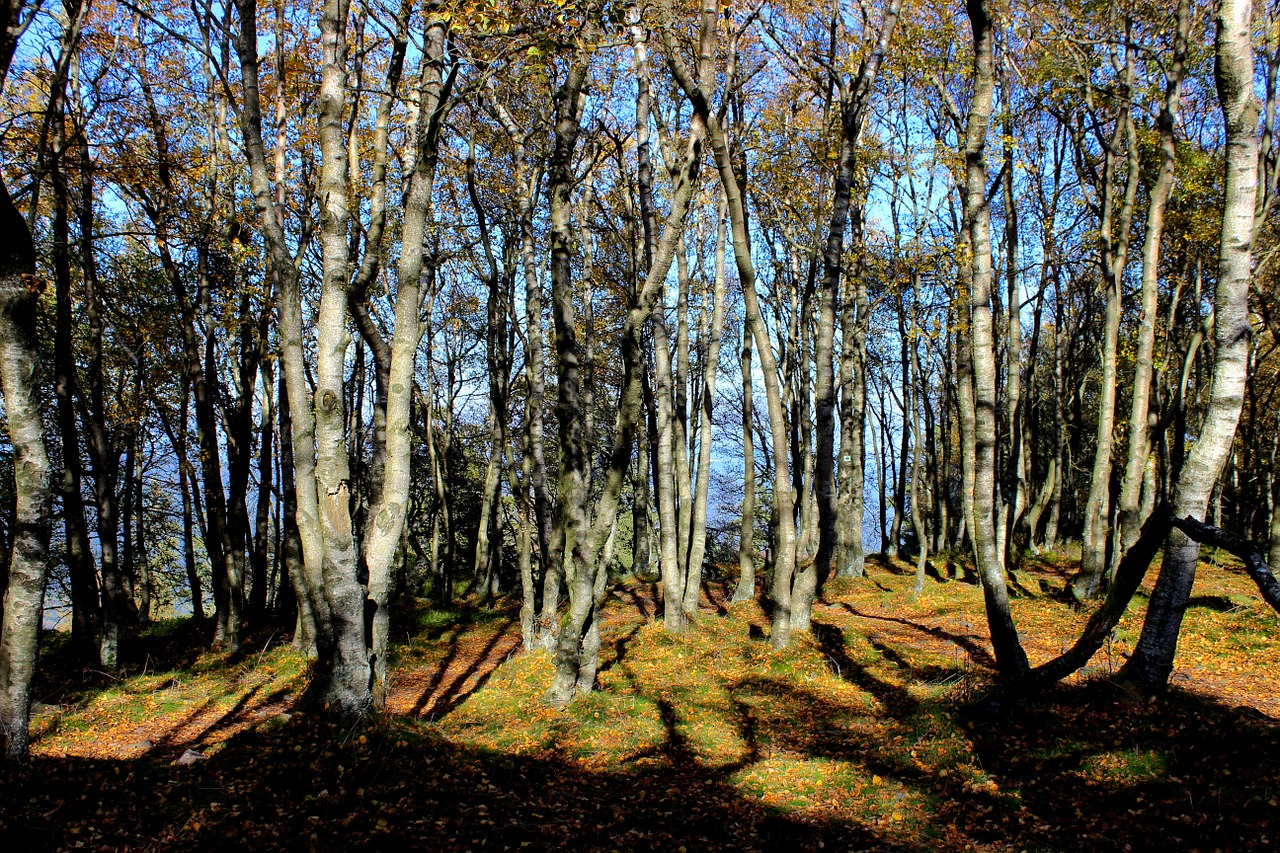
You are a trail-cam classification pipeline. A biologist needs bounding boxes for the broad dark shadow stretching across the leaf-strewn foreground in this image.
[10,648,1280,852]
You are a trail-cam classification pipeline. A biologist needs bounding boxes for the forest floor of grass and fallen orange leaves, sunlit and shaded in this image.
[0,548,1280,852]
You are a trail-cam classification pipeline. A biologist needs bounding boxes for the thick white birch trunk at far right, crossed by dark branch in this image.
[1121,0,1258,692]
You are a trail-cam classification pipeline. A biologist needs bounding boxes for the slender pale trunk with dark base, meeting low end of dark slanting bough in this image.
[964,0,1028,680]
